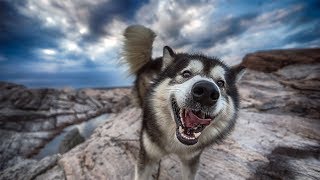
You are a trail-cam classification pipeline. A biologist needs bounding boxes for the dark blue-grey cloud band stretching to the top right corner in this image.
[170,1,320,49]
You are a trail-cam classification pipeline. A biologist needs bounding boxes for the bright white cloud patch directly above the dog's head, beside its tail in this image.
[135,0,216,57]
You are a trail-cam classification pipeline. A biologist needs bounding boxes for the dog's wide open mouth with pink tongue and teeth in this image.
[171,98,214,145]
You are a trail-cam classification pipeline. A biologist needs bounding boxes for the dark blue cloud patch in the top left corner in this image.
[0,1,62,57]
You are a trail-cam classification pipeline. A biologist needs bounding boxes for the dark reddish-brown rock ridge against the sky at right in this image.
[242,48,320,73]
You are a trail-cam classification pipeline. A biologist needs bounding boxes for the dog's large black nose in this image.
[191,80,220,106]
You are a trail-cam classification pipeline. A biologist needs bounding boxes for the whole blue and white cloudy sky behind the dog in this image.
[0,0,320,88]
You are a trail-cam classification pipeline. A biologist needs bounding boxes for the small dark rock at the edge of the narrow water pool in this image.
[59,128,85,154]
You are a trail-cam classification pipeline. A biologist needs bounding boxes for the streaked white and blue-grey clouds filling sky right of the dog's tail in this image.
[136,0,320,64]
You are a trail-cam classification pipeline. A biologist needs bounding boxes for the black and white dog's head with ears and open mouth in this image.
[153,46,244,145]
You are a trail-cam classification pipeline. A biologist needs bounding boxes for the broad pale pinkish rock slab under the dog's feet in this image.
[52,105,320,179]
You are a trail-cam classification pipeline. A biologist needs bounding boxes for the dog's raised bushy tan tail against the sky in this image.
[123,25,156,74]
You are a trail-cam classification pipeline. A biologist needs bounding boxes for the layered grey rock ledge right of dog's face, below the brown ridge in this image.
[240,63,320,118]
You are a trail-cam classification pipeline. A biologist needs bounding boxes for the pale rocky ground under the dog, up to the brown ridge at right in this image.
[0,49,320,180]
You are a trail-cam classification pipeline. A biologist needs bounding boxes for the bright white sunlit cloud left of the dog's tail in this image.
[20,0,127,69]
